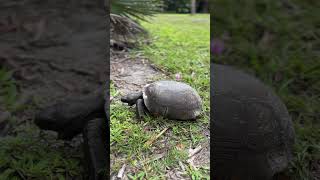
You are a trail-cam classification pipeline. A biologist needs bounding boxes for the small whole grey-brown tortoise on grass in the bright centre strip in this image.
[121,80,201,120]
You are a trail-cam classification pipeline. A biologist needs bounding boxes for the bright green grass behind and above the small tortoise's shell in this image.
[142,14,210,115]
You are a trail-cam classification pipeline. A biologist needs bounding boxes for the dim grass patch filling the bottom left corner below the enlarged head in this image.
[0,129,83,180]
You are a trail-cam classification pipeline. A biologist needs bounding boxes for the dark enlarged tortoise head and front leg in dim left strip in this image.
[34,88,109,180]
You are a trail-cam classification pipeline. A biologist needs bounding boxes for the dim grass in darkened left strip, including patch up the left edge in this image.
[0,69,84,180]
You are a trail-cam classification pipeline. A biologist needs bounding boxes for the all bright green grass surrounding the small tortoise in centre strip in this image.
[110,14,210,179]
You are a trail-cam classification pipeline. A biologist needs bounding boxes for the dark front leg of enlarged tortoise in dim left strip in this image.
[83,118,109,180]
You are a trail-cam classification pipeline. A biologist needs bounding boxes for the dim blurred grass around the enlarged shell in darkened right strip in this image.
[211,0,320,180]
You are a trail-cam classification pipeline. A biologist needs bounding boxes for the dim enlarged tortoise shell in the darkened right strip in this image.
[210,63,295,180]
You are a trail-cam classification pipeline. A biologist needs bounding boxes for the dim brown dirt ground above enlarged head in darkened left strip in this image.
[0,0,109,178]
